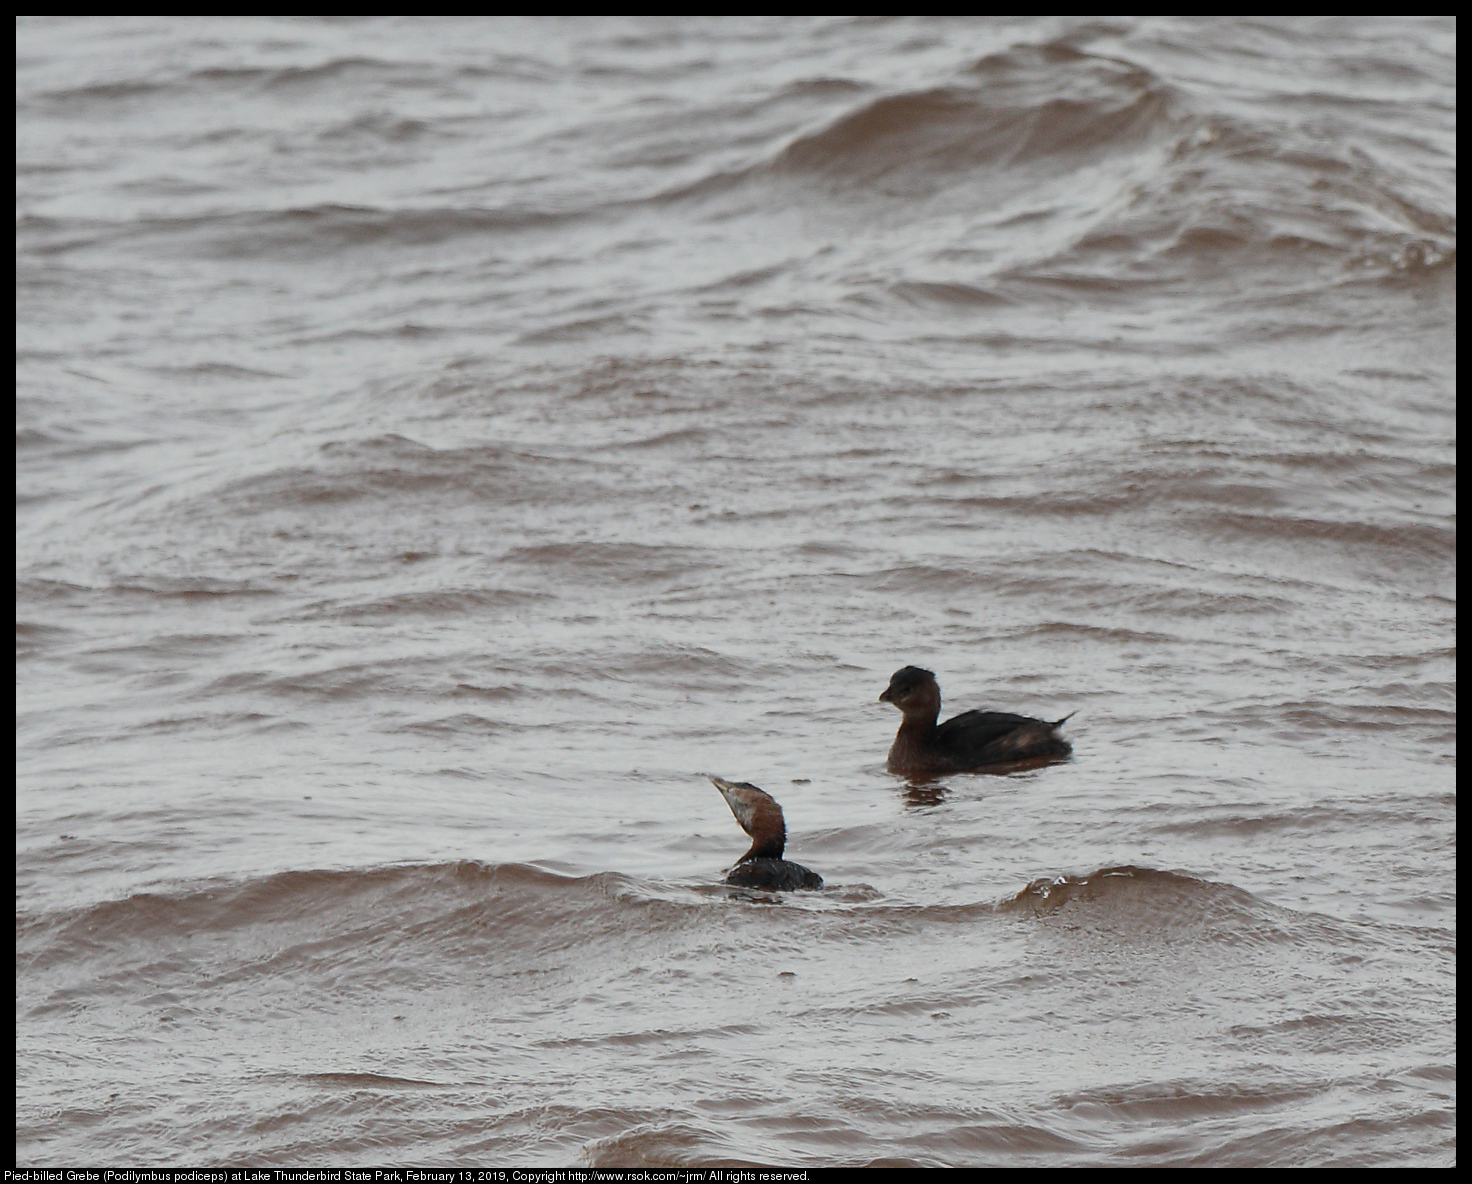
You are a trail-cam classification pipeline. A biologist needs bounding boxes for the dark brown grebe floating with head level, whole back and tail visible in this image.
[879,666,1073,773]
